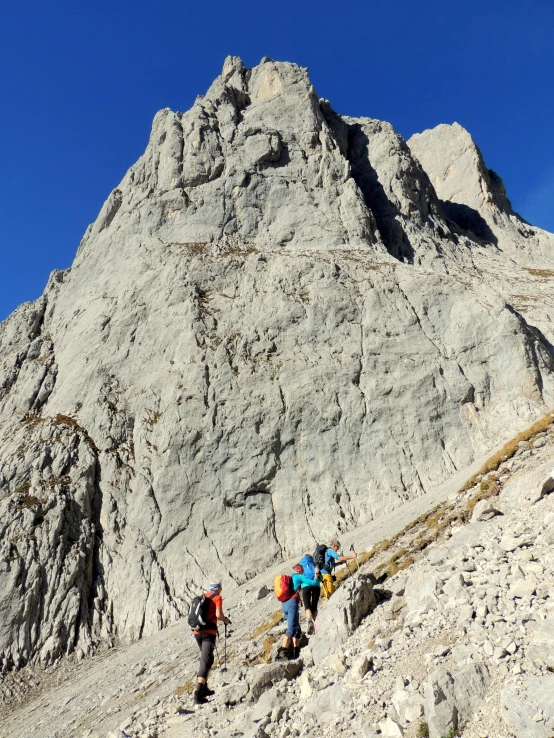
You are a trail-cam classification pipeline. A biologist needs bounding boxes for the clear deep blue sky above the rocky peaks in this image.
[0,0,554,320]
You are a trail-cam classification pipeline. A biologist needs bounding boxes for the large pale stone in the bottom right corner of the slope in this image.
[500,674,554,738]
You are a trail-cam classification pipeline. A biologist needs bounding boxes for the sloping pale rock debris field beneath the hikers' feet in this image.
[0,414,554,738]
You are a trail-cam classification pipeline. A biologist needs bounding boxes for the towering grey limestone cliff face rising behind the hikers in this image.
[0,57,554,668]
